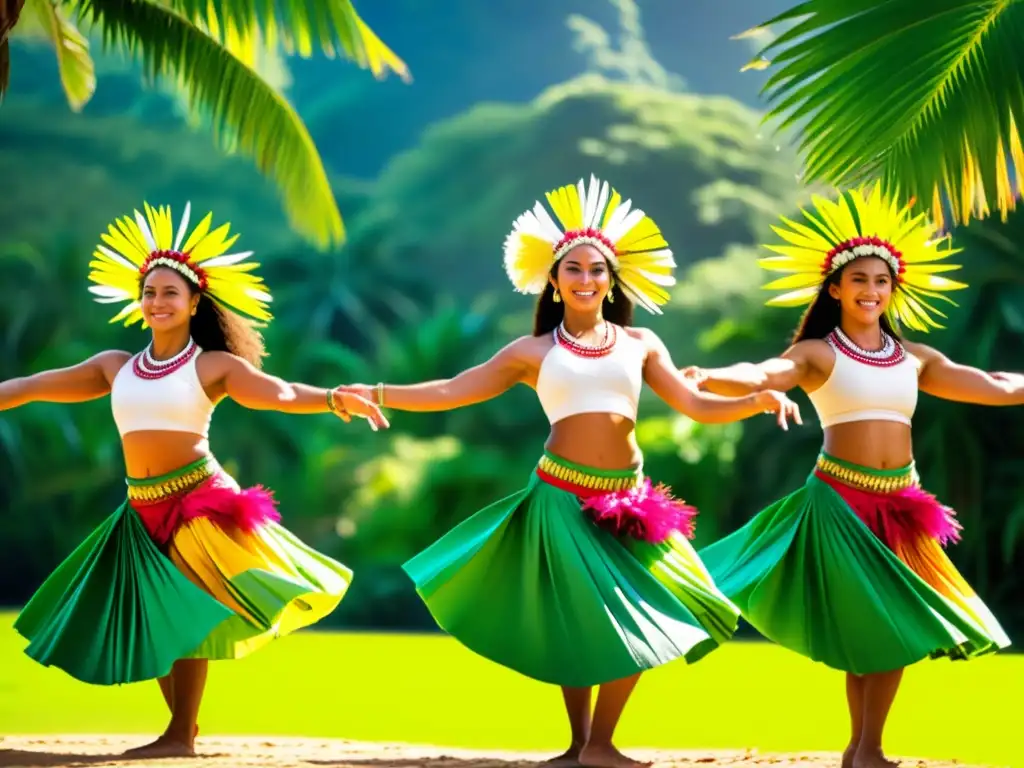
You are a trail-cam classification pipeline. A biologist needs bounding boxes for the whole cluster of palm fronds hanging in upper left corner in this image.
[0,0,409,248]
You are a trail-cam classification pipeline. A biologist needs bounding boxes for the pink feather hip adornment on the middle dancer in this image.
[577,477,697,544]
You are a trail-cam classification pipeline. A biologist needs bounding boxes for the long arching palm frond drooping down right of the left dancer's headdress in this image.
[81,0,344,248]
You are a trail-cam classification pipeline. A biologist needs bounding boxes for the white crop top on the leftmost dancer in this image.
[111,349,215,437]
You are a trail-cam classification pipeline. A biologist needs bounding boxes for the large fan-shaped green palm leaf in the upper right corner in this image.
[759,0,1024,225]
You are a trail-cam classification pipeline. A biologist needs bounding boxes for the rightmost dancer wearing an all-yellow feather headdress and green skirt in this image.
[686,185,1024,768]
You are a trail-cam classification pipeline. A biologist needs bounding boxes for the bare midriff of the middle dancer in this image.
[544,414,642,469]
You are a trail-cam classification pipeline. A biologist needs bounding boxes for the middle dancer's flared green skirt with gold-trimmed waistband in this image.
[403,455,738,687]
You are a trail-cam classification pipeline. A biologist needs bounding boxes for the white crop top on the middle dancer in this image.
[537,325,646,424]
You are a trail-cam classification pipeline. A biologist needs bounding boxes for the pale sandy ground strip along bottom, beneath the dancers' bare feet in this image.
[0,735,999,768]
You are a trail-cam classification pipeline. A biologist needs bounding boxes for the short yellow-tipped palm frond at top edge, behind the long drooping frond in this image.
[167,0,410,81]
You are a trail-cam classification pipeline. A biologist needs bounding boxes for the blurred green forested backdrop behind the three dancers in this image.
[0,0,1024,635]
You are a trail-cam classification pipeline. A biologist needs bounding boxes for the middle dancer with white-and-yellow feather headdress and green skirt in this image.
[342,177,799,768]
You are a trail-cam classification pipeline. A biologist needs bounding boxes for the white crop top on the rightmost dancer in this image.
[808,334,921,428]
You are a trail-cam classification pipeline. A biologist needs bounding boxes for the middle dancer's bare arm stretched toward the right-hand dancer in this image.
[643,331,803,429]
